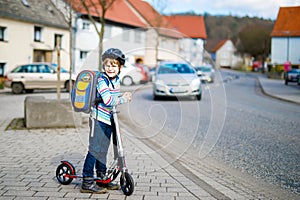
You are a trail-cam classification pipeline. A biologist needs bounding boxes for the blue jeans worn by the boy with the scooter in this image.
[82,117,112,177]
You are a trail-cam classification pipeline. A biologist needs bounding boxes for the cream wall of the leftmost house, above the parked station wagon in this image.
[0,18,70,72]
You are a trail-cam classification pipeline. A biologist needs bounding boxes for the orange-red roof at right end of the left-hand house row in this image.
[166,15,207,39]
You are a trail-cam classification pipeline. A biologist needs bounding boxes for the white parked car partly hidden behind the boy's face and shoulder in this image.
[119,61,142,86]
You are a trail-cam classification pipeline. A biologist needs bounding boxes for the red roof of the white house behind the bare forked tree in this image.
[69,0,146,27]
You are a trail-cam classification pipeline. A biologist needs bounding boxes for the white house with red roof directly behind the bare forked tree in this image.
[52,0,146,72]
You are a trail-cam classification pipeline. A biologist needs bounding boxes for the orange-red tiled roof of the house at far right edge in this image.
[271,6,300,37]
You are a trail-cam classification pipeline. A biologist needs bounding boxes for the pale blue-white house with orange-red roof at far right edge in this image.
[271,6,300,67]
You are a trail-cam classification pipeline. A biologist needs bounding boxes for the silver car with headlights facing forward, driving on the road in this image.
[153,62,202,100]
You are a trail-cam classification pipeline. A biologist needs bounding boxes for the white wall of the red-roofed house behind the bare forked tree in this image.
[75,19,146,72]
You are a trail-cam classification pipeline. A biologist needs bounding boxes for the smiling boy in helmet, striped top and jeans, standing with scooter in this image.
[81,48,132,194]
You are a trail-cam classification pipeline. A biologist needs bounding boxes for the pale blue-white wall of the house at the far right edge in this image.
[271,37,300,65]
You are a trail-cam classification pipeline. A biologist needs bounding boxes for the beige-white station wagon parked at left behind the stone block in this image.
[4,63,76,94]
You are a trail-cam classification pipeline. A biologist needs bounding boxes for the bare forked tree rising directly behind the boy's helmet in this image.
[80,0,116,71]
